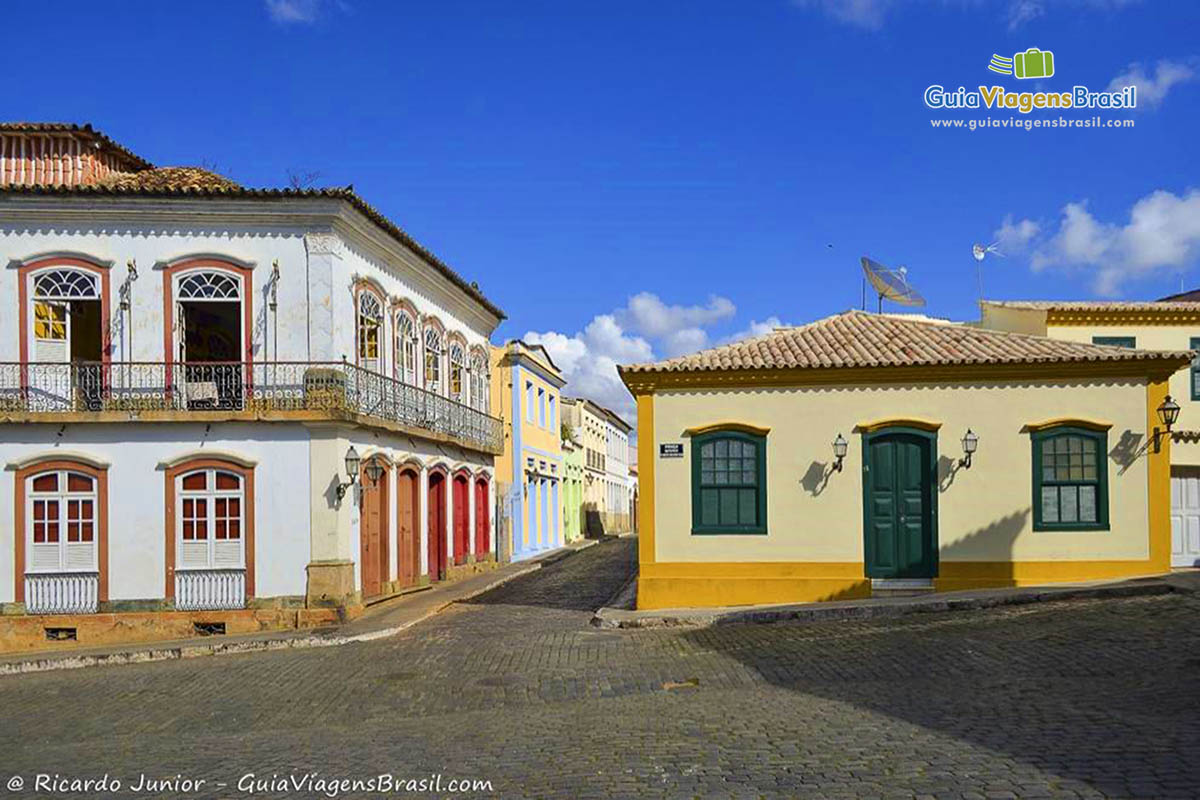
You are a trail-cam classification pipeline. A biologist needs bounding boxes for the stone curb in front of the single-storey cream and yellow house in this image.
[592,579,1180,628]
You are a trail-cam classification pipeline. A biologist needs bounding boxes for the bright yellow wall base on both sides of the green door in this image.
[637,561,1170,610]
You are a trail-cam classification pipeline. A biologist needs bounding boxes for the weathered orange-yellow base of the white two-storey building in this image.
[0,606,362,654]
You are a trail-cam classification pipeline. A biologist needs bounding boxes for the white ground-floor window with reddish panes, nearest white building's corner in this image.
[175,468,246,570]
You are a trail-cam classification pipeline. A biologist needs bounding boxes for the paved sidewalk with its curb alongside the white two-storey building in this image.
[0,540,599,675]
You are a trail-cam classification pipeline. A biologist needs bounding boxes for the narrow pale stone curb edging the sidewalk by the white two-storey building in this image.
[0,540,600,676]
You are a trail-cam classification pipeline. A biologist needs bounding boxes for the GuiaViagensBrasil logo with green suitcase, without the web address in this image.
[925,47,1138,114]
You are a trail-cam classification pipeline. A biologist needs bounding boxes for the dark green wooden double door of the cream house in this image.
[863,432,937,578]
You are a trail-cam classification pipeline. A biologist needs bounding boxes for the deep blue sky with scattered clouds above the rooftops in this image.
[0,0,1200,410]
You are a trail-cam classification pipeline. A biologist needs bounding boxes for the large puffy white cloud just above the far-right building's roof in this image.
[1031,190,1200,296]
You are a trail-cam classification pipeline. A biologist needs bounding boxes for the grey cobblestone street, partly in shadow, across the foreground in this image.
[0,539,1200,798]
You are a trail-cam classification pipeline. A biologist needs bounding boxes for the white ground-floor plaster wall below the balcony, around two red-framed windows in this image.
[0,422,310,602]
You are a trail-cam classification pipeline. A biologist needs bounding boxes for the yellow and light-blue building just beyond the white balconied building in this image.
[491,339,566,561]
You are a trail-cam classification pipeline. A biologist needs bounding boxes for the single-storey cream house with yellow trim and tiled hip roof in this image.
[620,311,1190,608]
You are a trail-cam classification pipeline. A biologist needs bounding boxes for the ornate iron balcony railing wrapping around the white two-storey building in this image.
[0,361,504,452]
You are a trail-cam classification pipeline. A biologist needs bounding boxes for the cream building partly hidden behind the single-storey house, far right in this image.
[980,299,1200,566]
